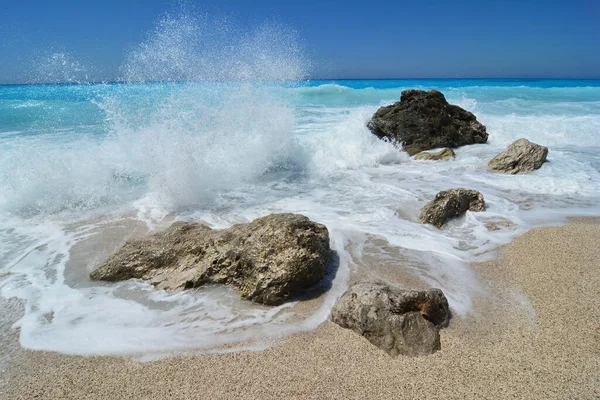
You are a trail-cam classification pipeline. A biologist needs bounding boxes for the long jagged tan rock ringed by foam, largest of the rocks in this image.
[90,214,331,305]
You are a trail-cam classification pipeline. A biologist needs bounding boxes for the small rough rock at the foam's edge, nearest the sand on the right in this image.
[419,189,485,228]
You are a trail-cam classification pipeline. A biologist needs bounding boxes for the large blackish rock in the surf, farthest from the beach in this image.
[367,90,488,156]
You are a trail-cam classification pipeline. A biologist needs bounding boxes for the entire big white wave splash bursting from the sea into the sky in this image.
[4,15,305,215]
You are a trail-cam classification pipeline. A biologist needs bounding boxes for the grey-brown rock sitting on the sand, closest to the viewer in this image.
[331,280,450,356]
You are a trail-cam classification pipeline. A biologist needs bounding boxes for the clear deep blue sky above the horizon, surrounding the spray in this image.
[0,0,600,83]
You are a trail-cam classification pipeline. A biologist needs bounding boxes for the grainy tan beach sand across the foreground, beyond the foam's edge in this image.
[2,219,600,399]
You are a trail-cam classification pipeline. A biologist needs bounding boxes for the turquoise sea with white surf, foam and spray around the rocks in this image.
[0,15,600,359]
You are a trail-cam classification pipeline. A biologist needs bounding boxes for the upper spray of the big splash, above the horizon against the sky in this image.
[122,14,309,82]
